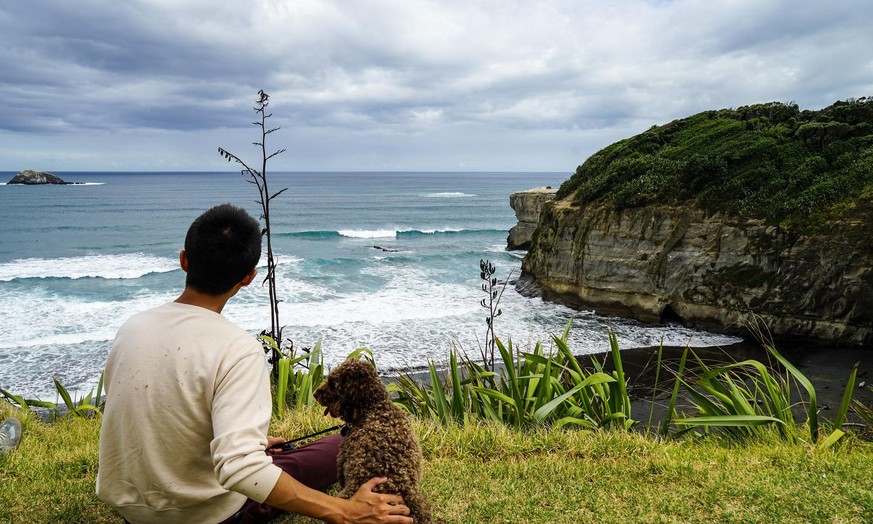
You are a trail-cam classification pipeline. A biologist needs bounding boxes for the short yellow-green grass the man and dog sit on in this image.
[0,402,873,524]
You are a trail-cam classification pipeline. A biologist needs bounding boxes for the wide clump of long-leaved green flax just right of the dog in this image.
[390,323,636,430]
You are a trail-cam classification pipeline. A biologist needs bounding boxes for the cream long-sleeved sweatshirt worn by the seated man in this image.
[97,302,281,524]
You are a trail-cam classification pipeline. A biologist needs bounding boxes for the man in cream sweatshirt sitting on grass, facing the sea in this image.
[96,204,412,524]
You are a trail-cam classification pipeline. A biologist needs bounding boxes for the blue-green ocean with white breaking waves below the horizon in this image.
[0,172,740,400]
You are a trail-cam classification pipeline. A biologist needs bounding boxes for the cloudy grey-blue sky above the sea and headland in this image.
[0,0,873,173]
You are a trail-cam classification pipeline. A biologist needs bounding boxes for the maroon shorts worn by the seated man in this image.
[221,435,343,524]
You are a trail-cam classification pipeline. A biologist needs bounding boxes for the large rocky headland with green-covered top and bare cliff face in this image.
[510,99,873,347]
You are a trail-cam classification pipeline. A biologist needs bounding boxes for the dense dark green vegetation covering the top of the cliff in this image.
[557,97,873,222]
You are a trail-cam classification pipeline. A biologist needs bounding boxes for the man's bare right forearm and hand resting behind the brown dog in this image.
[264,472,412,524]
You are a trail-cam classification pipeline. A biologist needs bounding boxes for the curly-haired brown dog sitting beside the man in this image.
[315,360,433,524]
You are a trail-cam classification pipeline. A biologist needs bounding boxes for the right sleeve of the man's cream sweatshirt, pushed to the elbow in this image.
[210,342,282,502]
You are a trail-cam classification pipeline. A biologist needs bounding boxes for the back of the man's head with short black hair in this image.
[185,204,261,295]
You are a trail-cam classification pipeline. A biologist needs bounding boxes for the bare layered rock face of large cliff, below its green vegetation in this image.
[520,195,873,347]
